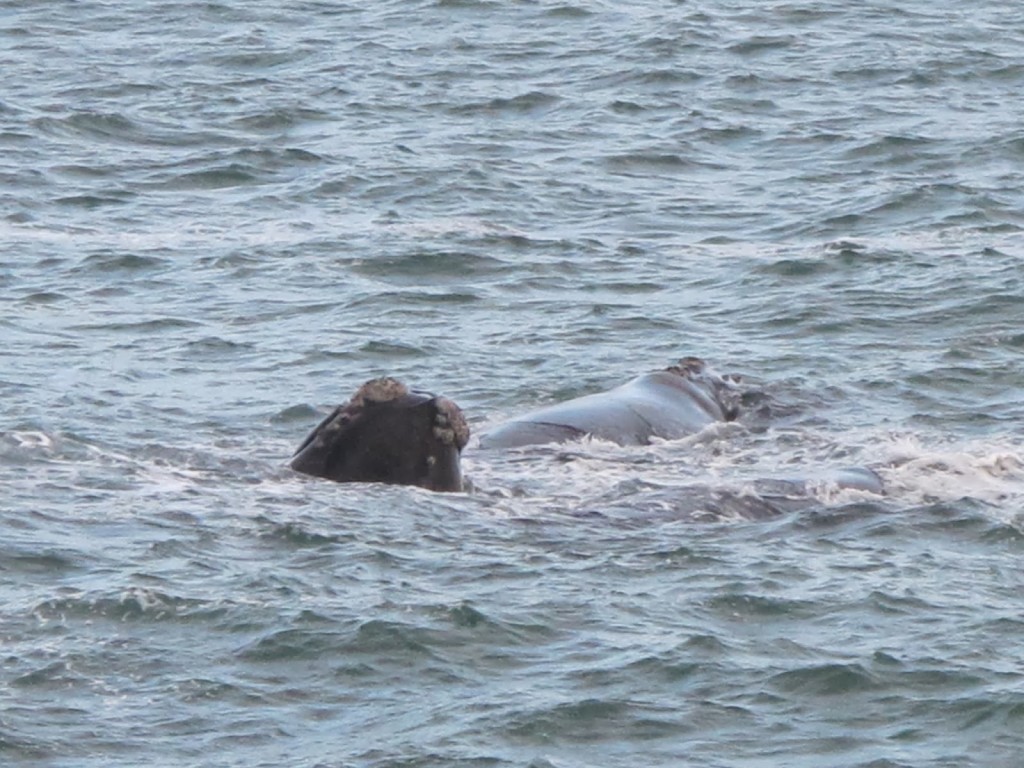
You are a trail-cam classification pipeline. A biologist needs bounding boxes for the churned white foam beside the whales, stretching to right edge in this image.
[464,417,1024,520]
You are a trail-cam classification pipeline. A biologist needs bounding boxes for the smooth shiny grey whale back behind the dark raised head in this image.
[480,357,739,449]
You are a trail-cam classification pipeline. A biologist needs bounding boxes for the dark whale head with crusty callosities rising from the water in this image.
[291,378,469,490]
